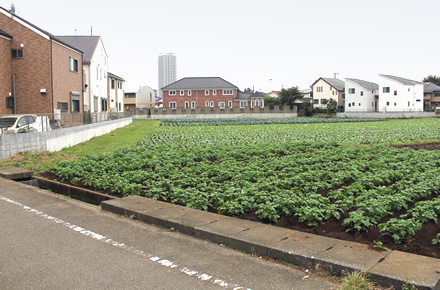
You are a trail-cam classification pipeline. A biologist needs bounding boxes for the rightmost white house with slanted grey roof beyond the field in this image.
[378,75,423,112]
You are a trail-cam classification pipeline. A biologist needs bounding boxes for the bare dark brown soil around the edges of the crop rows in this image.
[42,142,440,258]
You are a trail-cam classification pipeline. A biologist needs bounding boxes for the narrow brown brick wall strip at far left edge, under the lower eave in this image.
[0,36,13,114]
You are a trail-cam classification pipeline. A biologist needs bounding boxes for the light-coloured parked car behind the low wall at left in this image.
[0,114,51,134]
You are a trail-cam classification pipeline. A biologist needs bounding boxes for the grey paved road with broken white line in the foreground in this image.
[0,178,337,289]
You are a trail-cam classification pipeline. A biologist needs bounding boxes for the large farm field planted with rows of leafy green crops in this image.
[54,119,440,258]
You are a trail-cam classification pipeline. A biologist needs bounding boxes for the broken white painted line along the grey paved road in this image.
[0,195,251,290]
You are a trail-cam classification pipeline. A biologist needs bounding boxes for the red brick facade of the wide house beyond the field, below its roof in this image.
[163,89,237,108]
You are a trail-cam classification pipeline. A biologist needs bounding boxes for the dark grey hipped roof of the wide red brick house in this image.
[162,77,238,90]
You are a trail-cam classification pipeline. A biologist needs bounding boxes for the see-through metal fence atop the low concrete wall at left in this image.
[0,112,132,134]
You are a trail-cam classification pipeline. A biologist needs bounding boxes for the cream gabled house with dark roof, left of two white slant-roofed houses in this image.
[310,77,345,112]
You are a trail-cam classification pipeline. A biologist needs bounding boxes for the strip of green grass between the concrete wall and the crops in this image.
[0,120,160,175]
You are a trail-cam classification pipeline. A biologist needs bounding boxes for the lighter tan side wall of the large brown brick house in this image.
[52,41,83,112]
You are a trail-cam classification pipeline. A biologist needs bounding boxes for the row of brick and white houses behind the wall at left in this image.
[0,7,125,114]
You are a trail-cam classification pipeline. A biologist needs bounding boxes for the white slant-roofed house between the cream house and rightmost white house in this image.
[345,78,379,112]
